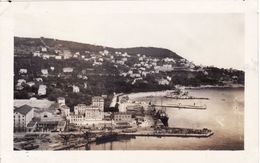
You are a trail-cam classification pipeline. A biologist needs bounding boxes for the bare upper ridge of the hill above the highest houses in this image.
[14,37,182,59]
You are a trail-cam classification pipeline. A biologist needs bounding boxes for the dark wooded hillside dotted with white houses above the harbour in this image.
[14,37,244,106]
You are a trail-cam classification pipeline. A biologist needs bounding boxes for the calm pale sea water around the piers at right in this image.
[87,88,244,150]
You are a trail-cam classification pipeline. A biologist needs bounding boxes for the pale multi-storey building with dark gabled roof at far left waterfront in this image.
[14,105,34,132]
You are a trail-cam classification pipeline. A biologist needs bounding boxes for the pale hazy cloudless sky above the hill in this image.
[15,3,245,70]
